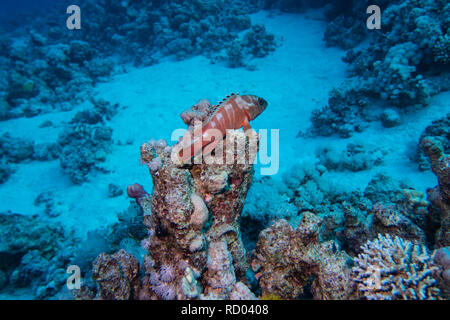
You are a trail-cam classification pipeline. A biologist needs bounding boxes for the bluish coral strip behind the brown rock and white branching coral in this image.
[246,163,434,255]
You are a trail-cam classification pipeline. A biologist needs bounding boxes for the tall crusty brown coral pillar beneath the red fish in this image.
[79,96,253,299]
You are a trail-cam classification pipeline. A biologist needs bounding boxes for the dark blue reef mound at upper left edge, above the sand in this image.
[0,33,113,119]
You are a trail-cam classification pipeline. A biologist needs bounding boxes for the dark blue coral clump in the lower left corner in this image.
[0,213,76,299]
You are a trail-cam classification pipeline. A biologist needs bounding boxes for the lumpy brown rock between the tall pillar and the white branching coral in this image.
[252,218,355,299]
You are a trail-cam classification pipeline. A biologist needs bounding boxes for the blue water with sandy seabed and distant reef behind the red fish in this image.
[0,0,450,299]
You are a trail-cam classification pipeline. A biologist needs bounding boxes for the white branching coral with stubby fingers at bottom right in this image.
[353,234,440,300]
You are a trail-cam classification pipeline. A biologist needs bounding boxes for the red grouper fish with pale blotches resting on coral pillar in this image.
[178,94,267,164]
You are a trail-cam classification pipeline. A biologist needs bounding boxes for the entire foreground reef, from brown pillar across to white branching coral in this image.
[75,95,448,300]
